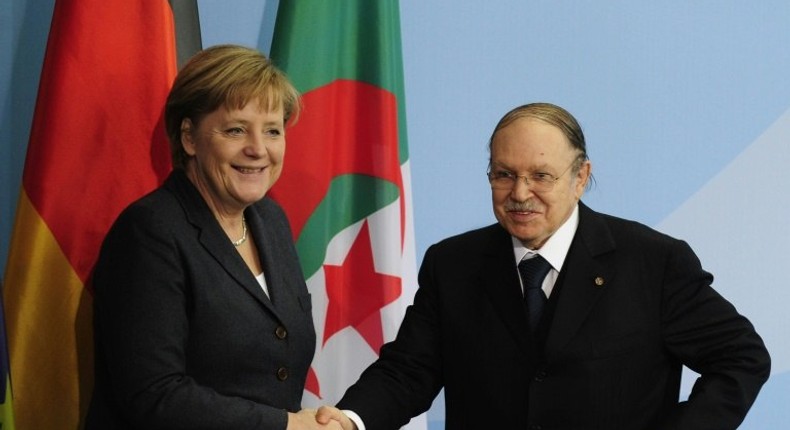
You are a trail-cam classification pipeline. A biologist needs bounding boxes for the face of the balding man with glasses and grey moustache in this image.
[491,118,591,249]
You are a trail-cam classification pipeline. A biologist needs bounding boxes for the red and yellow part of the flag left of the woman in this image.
[2,0,176,430]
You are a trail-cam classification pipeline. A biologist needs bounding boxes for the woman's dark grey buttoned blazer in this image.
[87,170,315,430]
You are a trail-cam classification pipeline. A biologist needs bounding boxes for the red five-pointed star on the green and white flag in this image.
[323,221,401,354]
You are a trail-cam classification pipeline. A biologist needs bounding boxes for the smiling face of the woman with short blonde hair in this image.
[181,100,285,216]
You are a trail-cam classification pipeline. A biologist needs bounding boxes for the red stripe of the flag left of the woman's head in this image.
[23,0,176,282]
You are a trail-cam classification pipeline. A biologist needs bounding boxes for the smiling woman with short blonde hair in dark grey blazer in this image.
[86,45,334,430]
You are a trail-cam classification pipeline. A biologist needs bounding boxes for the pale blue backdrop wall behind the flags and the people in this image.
[0,0,790,430]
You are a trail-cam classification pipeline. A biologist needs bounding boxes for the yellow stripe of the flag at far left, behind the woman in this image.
[3,190,93,430]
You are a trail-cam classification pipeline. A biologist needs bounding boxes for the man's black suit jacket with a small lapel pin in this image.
[338,203,770,430]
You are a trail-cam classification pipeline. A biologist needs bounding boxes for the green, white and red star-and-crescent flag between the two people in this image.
[271,0,426,429]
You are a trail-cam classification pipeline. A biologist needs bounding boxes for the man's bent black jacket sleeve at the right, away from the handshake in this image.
[660,240,770,430]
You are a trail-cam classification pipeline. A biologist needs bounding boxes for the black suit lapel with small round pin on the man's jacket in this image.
[545,202,616,360]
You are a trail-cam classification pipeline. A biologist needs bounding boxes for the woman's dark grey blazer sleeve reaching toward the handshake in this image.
[94,202,287,430]
